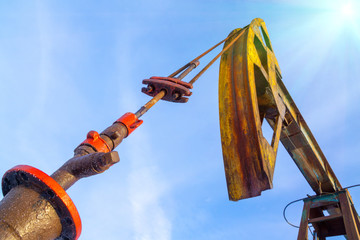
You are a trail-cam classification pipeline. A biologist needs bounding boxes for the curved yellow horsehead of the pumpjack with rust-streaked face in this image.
[219,19,283,200]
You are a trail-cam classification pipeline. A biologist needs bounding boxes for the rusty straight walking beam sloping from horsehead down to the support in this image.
[277,73,342,194]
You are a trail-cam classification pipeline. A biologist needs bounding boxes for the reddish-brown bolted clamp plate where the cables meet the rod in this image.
[141,77,192,103]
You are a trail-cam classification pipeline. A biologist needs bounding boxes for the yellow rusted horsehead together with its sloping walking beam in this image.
[219,19,341,201]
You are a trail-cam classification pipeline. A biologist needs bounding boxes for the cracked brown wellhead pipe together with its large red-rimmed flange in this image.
[0,165,81,240]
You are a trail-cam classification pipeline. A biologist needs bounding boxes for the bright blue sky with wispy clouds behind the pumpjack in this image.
[0,0,360,240]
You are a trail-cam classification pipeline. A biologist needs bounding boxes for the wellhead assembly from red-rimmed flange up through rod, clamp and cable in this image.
[0,19,236,240]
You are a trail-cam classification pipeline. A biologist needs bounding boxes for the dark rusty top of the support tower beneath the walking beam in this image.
[297,190,360,240]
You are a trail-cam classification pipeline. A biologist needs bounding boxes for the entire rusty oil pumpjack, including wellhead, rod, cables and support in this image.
[0,18,360,240]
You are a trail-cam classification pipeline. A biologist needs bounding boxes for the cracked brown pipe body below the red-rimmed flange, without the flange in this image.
[0,186,62,240]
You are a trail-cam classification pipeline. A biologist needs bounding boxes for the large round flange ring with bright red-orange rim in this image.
[2,165,81,239]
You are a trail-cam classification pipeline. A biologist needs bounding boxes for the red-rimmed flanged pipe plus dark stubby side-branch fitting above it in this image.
[0,151,120,240]
